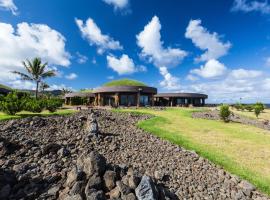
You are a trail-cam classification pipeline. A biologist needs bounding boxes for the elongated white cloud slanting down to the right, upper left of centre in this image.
[75,18,123,54]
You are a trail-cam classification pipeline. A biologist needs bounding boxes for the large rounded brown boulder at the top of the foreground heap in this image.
[77,151,106,177]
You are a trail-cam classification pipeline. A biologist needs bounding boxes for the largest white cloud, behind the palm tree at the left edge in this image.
[0,22,70,84]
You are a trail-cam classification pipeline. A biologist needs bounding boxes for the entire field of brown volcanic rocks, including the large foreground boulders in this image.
[0,110,268,200]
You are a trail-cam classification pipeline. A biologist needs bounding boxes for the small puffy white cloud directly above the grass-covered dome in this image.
[107,54,146,75]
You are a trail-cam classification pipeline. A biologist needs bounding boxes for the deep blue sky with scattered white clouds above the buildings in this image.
[0,0,270,103]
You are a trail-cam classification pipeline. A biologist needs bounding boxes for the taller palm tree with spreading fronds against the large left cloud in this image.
[13,58,56,98]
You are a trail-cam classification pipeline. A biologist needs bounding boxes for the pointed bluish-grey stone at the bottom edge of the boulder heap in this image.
[135,176,158,200]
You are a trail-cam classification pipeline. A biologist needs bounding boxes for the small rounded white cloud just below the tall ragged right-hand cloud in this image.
[190,59,227,78]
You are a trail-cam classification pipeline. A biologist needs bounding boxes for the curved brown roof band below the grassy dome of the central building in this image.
[93,85,157,94]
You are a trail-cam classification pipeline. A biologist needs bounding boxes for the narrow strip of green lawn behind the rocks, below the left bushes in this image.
[0,109,76,121]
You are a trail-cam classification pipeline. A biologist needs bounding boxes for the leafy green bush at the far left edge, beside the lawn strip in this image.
[0,92,25,115]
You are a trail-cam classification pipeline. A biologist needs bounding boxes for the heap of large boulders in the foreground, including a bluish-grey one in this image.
[58,151,173,200]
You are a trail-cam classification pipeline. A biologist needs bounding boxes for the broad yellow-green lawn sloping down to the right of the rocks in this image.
[116,108,270,195]
